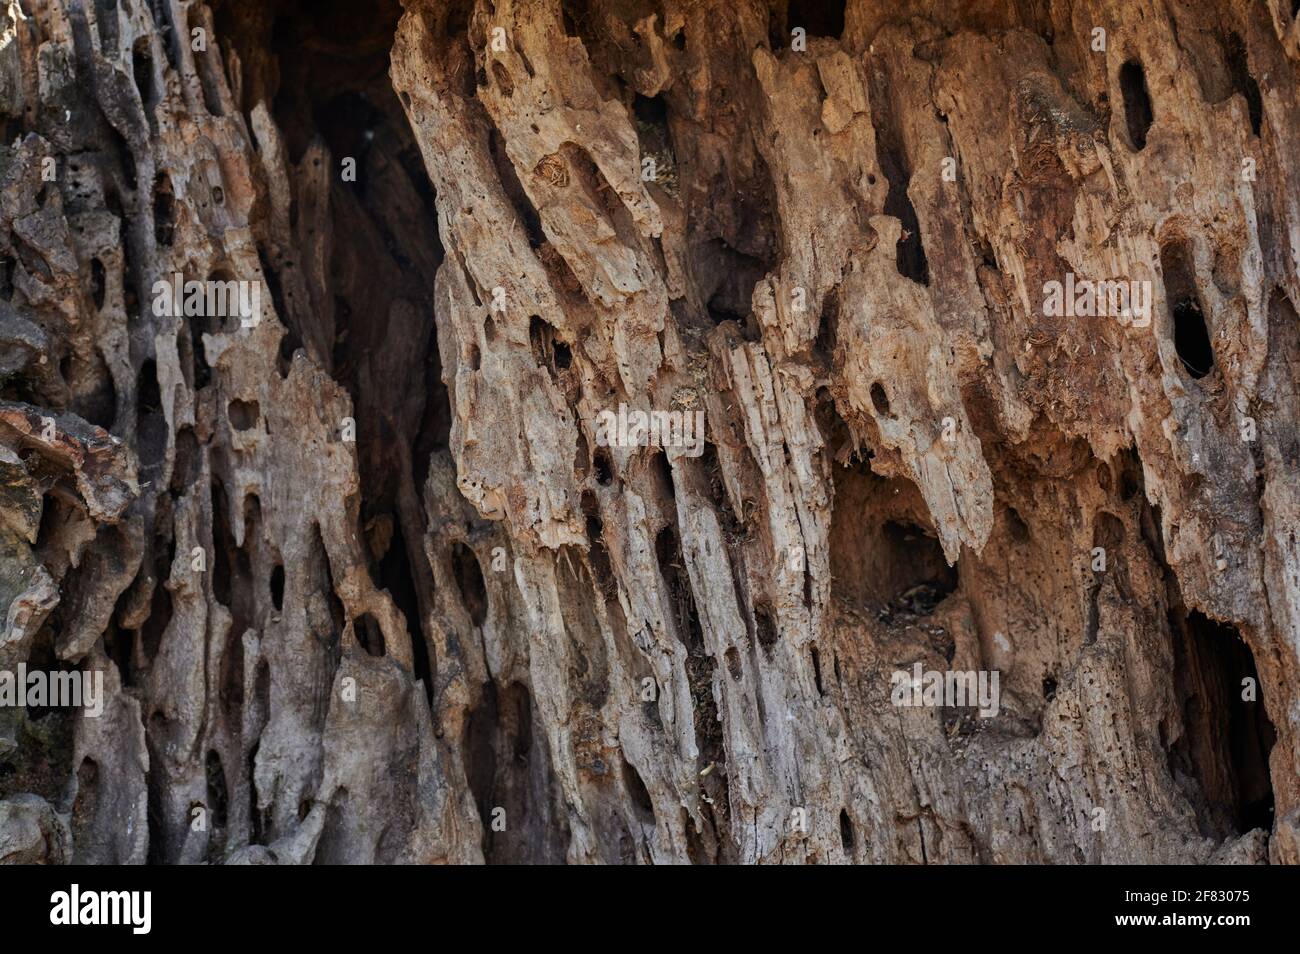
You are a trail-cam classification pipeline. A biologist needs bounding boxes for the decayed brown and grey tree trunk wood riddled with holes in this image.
[0,0,1300,863]
